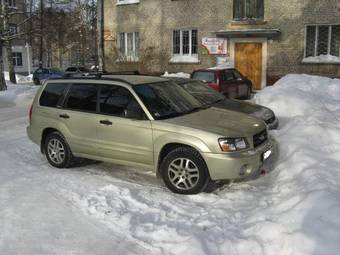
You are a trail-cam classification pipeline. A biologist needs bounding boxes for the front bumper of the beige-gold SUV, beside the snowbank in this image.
[202,137,279,180]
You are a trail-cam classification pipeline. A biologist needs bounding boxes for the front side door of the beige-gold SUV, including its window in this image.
[97,85,154,167]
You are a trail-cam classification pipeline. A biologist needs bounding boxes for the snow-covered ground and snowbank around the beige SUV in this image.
[0,75,340,255]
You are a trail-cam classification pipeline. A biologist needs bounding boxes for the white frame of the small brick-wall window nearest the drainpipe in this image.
[117,32,140,62]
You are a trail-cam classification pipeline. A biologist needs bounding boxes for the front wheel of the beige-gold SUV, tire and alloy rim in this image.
[160,147,210,195]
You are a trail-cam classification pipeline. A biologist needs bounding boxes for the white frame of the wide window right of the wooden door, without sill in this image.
[303,24,340,58]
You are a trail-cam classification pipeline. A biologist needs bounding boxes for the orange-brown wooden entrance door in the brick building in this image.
[235,43,262,90]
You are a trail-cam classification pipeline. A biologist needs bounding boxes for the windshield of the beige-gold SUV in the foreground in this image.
[133,81,205,119]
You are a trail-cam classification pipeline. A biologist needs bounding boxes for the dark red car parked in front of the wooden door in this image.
[191,68,252,99]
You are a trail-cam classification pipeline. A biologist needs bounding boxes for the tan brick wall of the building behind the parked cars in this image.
[104,0,340,79]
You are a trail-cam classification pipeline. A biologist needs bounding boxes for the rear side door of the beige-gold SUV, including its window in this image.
[58,83,98,155]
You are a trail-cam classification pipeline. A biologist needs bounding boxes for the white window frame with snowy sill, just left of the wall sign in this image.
[170,29,200,63]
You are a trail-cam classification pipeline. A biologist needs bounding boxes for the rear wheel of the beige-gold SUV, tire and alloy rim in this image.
[44,132,74,168]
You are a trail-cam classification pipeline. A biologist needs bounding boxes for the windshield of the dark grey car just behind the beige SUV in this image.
[180,81,225,105]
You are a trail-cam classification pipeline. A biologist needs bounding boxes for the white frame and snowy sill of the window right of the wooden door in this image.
[302,24,340,64]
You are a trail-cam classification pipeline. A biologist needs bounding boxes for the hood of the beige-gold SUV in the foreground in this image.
[164,107,266,137]
